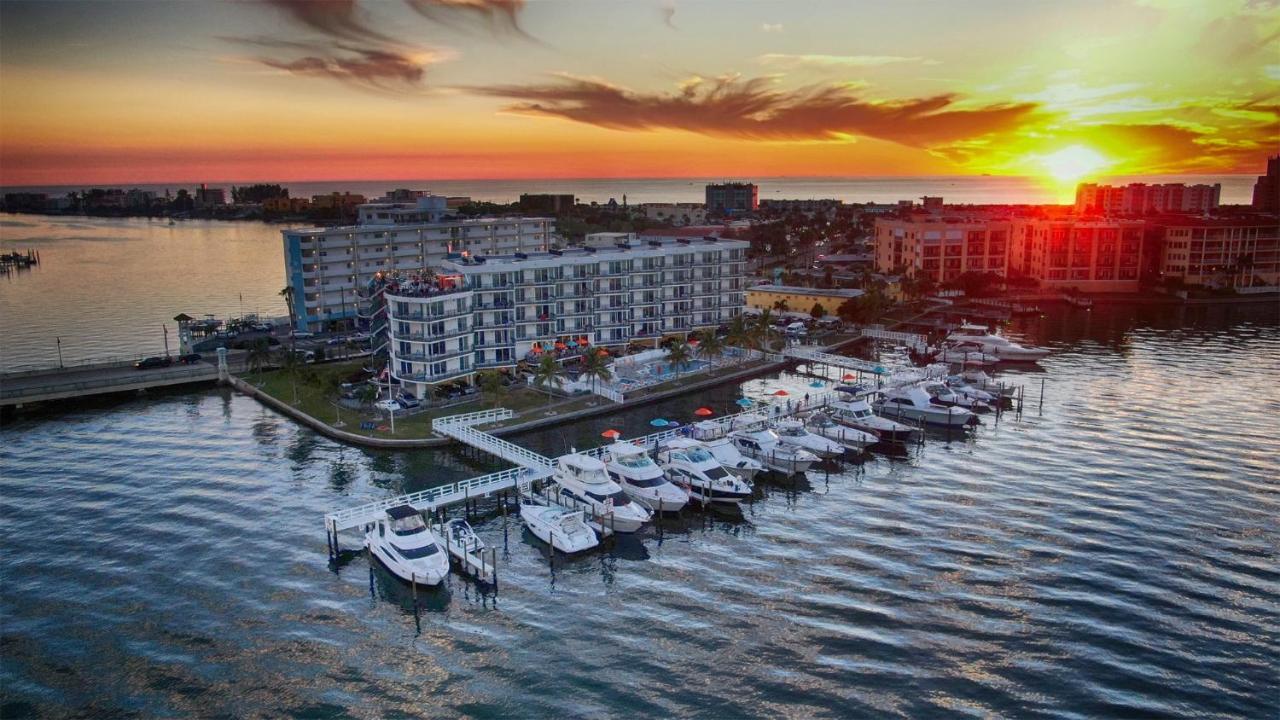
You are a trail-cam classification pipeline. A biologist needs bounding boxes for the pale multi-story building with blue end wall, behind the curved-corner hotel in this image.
[280,218,556,332]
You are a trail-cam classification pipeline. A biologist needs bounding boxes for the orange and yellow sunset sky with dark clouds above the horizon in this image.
[0,0,1280,184]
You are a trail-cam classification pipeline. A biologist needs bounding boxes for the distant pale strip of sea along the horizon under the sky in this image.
[6,168,1262,205]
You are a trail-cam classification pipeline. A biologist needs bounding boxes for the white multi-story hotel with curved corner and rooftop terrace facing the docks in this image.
[384,238,749,397]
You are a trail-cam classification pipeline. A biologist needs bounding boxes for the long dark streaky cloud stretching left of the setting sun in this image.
[470,77,1037,147]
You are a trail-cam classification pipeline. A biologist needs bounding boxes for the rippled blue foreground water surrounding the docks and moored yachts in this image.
[0,307,1280,719]
